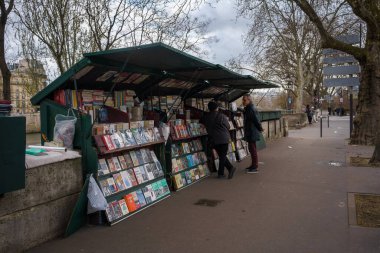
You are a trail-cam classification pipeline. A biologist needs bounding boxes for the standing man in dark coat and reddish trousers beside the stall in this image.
[243,94,264,173]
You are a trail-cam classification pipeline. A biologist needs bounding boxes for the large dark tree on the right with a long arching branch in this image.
[293,0,380,162]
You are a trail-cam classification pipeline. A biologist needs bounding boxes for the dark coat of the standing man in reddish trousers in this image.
[244,104,263,142]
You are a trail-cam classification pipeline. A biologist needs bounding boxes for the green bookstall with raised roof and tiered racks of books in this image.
[31,43,276,235]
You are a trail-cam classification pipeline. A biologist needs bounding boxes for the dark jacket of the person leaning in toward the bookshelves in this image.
[201,111,230,145]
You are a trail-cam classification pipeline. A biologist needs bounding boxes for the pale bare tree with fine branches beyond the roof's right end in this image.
[233,0,355,111]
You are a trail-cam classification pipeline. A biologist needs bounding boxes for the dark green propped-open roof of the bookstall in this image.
[31,43,277,105]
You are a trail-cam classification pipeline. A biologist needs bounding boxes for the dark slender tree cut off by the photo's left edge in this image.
[0,0,14,100]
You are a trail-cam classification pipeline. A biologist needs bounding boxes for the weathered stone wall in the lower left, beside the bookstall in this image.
[0,158,83,252]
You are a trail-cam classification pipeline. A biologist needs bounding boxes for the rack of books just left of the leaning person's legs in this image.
[166,119,210,191]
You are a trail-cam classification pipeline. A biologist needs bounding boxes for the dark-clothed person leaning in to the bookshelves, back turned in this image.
[201,101,236,179]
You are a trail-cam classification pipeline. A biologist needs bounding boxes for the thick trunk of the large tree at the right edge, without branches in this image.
[351,32,380,162]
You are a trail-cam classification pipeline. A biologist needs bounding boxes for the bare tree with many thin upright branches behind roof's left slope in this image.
[16,0,87,73]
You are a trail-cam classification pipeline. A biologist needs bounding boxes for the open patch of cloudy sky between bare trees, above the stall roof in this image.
[193,0,248,65]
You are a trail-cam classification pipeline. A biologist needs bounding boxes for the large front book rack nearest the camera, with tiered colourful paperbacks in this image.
[93,122,170,225]
